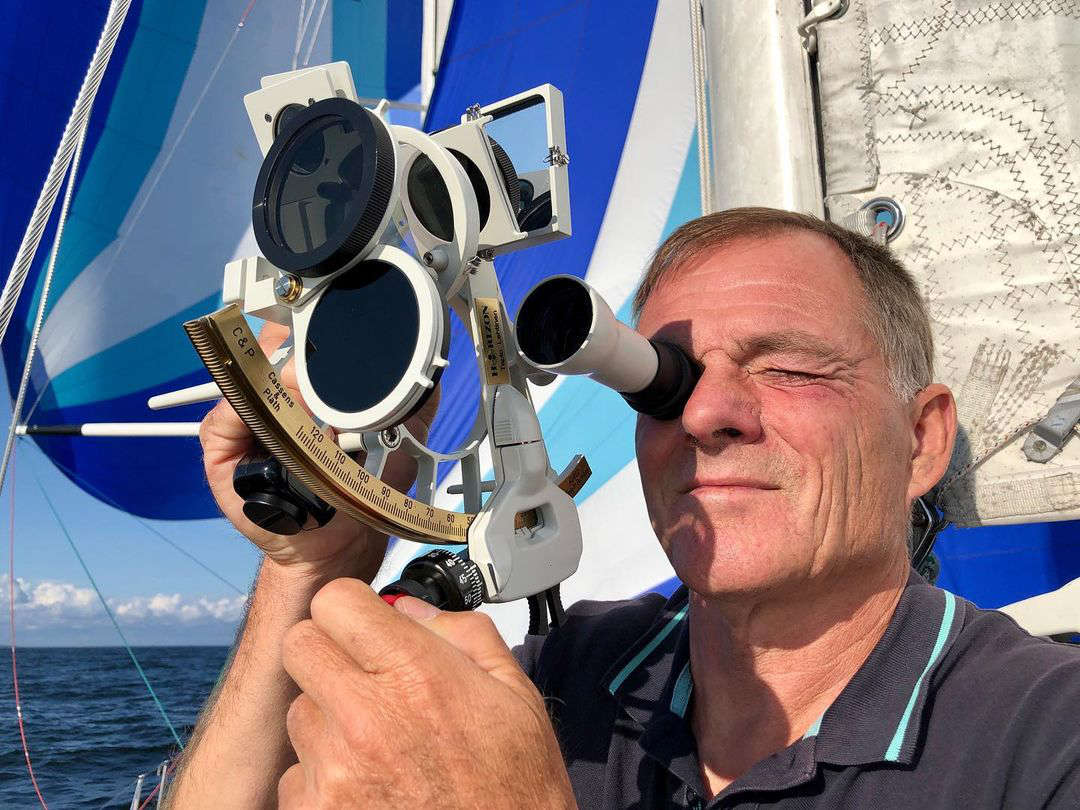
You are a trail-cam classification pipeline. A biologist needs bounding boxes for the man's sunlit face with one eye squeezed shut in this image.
[637,231,915,596]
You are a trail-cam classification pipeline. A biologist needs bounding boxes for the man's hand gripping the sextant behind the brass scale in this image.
[199,322,438,576]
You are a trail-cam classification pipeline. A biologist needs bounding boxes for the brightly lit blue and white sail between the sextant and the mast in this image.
[383,0,701,638]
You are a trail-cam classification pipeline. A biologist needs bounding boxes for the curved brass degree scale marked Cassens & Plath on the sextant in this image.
[184,305,590,543]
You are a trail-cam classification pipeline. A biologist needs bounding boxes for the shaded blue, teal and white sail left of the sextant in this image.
[0,0,423,518]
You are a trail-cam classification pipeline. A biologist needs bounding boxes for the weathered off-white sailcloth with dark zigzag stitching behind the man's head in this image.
[819,0,1080,526]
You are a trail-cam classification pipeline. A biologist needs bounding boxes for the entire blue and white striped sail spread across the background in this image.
[0,0,1080,637]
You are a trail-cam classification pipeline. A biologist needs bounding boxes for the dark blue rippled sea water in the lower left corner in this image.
[0,647,229,810]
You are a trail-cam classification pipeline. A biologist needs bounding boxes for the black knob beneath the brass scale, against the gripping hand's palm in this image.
[232,453,334,535]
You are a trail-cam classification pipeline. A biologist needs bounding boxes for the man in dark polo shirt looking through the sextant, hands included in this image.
[172,208,1080,808]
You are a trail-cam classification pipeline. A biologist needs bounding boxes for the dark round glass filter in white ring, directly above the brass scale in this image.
[305,260,428,413]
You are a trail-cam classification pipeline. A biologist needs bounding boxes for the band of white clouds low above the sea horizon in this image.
[0,573,246,629]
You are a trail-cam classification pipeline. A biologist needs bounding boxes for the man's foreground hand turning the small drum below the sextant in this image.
[278,579,575,810]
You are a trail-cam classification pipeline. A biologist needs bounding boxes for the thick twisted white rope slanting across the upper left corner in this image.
[0,0,131,349]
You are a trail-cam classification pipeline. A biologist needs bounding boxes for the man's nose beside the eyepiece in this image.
[681,364,761,447]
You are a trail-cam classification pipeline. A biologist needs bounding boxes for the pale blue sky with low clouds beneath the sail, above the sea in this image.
[0,382,258,646]
